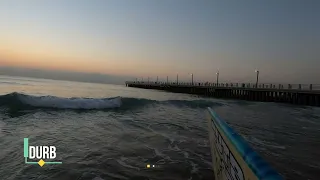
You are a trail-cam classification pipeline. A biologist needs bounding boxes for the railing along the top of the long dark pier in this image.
[126,81,320,91]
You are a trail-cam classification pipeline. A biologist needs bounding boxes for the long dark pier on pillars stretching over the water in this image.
[125,79,320,106]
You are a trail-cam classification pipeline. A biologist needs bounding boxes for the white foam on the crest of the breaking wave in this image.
[18,94,122,109]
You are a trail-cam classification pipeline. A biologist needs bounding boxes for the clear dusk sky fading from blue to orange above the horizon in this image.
[0,0,320,84]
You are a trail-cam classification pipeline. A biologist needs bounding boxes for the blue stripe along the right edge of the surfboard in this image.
[208,108,283,180]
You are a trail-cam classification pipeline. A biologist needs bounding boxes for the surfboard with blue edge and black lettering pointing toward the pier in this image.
[208,108,283,180]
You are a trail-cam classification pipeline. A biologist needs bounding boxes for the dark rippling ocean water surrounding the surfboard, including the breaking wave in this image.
[0,76,320,180]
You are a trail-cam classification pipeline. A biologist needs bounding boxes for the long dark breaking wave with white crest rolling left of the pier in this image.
[0,92,222,110]
